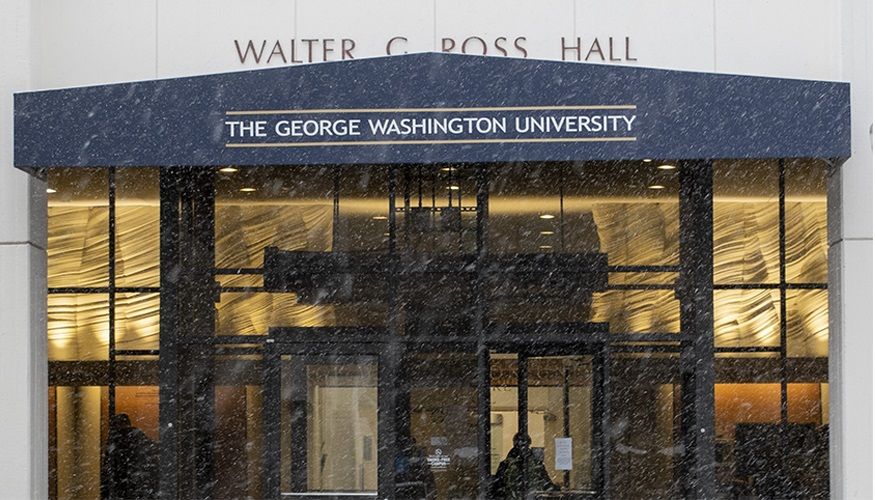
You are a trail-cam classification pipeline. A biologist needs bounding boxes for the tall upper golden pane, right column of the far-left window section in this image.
[115,167,160,287]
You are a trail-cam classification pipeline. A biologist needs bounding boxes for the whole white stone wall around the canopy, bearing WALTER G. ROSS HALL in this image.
[0,0,872,498]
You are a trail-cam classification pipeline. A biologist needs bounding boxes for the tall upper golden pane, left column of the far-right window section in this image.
[714,160,780,283]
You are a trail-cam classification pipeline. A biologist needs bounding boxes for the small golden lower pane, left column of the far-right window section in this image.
[714,290,781,347]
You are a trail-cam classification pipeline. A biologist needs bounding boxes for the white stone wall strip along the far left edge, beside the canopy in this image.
[0,0,48,498]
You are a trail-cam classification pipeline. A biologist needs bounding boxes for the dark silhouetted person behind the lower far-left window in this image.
[100,413,158,500]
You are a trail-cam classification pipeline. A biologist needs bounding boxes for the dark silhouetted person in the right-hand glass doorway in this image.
[490,432,559,499]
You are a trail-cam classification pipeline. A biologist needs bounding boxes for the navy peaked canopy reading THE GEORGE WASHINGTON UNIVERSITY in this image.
[14,53,850,170]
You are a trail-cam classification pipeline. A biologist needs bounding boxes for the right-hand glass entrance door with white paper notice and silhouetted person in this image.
[489,352,604,499]
